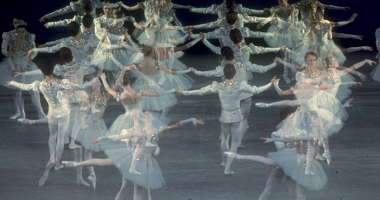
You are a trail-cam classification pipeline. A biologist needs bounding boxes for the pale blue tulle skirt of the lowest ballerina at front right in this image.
[268,149,327,191]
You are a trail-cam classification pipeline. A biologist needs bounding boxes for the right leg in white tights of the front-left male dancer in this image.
[54,116,70,170]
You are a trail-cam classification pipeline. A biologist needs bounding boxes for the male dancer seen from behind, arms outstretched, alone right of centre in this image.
[177,64,276,175]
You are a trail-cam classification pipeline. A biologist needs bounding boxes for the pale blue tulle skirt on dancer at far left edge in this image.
[0,58,45,89]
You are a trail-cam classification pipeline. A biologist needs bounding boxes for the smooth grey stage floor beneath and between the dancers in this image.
[0,53,380,200]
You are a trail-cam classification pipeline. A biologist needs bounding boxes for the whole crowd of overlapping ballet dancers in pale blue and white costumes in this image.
[0,0,380,200]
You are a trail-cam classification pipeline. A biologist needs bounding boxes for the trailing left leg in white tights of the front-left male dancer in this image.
[38,119,58,186]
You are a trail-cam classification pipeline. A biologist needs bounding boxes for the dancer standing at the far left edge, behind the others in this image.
[0,24,46,119]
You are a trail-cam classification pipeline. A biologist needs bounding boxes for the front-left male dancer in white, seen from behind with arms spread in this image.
[7,61,98,186]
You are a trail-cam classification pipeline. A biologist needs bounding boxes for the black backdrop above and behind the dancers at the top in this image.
[0,0,380,57]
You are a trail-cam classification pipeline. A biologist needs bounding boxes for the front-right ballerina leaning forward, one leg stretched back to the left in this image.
[225,99,352,194]
